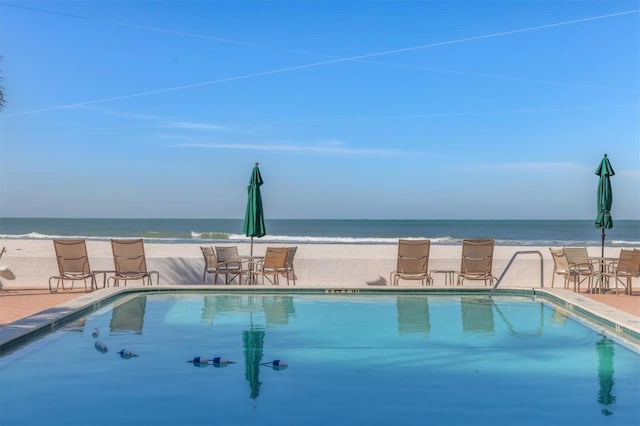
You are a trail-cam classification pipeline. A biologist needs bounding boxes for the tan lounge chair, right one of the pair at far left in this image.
[107,238,160,287]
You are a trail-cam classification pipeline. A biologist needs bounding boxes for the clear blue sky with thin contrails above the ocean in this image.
[0,0,640,219]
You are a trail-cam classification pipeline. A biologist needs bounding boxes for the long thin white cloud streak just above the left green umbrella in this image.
[172,140,408,156]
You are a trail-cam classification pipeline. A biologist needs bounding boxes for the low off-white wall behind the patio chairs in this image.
[0,239,620,288]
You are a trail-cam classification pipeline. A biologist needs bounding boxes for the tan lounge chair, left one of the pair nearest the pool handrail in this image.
[389,239,433,286]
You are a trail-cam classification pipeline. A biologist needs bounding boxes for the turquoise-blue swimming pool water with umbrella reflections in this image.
[0,292,640,425]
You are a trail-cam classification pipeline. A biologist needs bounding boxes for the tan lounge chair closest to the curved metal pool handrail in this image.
[458,240,497,286]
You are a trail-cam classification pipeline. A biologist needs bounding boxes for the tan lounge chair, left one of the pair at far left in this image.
[49,240,97,293]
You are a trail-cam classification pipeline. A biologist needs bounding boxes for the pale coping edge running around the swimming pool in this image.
[0,285,640,356]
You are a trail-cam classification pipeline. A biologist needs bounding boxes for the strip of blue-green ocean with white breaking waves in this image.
[0,218,640,247]
